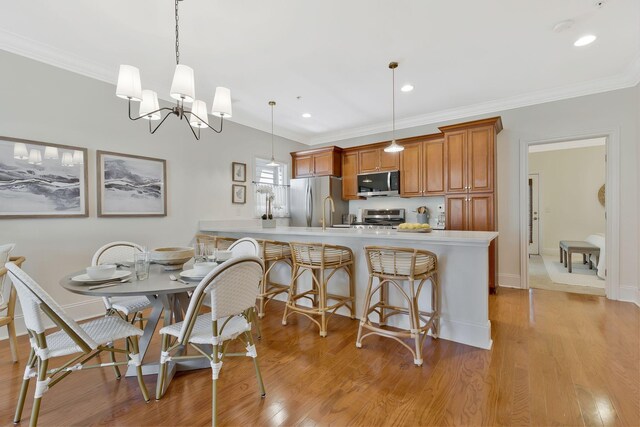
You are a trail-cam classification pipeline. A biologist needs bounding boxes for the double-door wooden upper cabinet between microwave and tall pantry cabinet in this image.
[400,134,445,197]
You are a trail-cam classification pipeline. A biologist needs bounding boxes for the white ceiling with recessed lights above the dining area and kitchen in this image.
[0,0,640,144]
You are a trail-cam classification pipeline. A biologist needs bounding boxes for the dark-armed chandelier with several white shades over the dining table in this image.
[116,0,231,140]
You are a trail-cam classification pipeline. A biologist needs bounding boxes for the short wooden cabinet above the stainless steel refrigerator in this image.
[291,147,342,178]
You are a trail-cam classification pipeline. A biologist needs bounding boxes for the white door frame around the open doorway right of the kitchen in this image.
[520,129,620,300]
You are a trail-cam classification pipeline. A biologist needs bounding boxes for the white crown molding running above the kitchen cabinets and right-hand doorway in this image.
[304,57,640,145]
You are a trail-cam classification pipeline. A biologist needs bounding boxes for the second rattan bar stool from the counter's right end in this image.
[282,242,355,337]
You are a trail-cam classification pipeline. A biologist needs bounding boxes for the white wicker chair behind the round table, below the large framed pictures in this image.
[91,241,151,327]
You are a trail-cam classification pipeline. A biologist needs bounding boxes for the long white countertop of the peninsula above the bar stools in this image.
[200,220,498,246]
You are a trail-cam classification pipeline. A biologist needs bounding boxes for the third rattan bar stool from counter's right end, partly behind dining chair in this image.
[258,240,293,319]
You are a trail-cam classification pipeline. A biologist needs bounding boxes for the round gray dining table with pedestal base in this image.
[60,264,209,398]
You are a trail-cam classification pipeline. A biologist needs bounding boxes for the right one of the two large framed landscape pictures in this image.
[96,151,167,217]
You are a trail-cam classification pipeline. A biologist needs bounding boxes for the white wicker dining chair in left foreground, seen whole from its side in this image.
[5,262,149,426]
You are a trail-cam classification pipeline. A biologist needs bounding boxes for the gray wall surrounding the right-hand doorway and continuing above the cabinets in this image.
[327,86,640,301]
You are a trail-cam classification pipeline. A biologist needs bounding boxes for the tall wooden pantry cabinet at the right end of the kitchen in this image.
[440,117,502,292]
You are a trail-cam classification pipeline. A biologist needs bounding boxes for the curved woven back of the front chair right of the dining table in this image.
[178,255,264,343]
